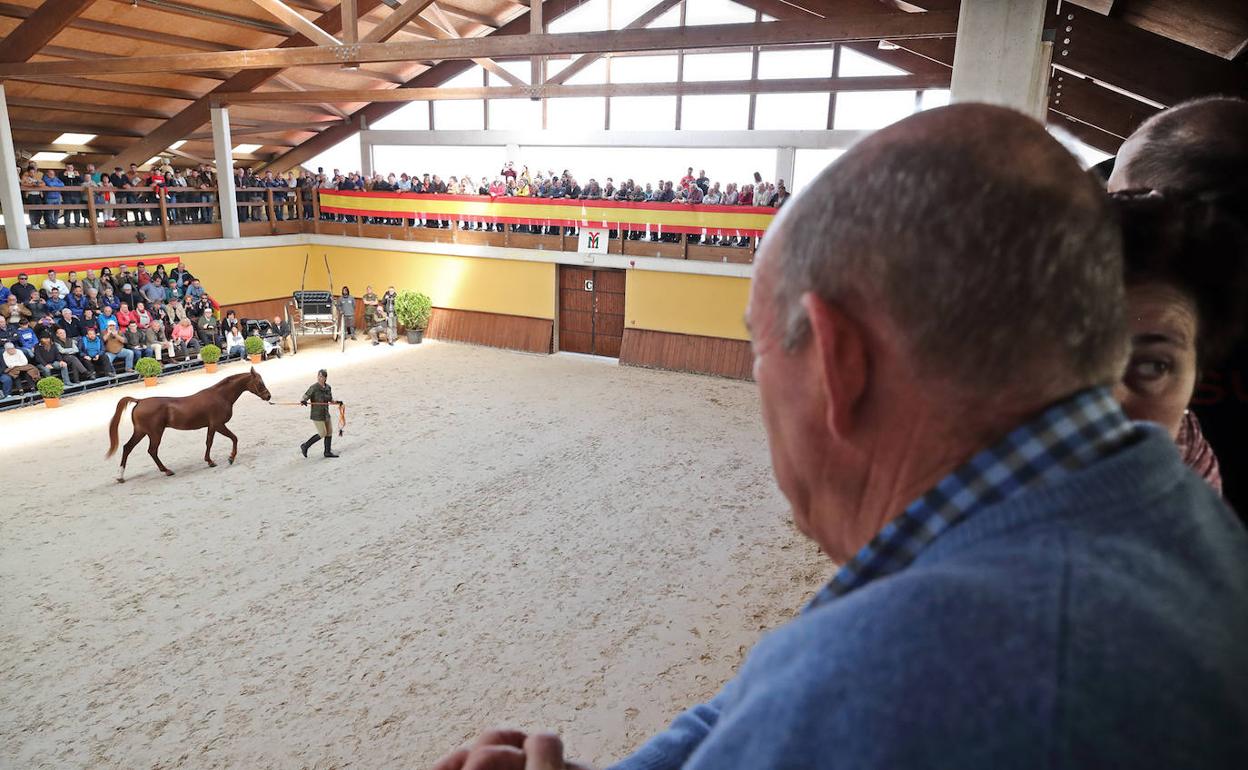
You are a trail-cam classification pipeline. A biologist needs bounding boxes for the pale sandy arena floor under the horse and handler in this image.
[0,343,831,770]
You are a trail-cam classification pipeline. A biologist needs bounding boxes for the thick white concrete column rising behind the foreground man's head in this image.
[951,0,1048,119]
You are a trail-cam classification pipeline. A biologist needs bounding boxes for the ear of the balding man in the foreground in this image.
[801,292,870,437]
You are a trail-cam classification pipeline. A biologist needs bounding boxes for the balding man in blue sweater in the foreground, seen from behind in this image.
[438,105,1248,770]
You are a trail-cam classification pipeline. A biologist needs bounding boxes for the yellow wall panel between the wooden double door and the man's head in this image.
[624,270,750,339]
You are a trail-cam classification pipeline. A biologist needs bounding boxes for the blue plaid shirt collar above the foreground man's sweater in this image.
[807,388,1139,609]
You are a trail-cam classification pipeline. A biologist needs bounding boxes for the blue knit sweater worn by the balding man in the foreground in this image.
[613,429,1248,770]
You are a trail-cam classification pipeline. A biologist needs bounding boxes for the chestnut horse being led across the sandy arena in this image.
[105,368,272,483]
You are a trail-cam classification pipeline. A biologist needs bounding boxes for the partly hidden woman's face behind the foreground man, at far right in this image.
[1114,283,1197,437]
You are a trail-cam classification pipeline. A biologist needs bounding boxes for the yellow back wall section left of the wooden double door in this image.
[310,246,555,318]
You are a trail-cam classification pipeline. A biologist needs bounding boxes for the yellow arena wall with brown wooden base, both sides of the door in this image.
[14,236,753,378]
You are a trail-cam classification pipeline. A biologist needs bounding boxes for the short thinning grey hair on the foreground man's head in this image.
[773,105,1127,394]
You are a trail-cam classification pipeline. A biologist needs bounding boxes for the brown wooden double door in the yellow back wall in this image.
[559,265,624,358]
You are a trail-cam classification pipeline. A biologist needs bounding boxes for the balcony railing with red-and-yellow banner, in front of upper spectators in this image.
[6,186,775,262]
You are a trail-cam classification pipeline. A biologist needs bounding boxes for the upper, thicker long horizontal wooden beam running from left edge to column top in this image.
[0,11,957,77]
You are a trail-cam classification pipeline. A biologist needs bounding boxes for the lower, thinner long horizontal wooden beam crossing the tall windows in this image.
[215,72,950,105]
